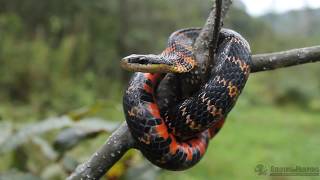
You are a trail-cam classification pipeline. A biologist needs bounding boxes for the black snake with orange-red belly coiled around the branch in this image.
[121,28,252,171]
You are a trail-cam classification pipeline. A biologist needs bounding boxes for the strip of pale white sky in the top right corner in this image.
[242,0,320,16]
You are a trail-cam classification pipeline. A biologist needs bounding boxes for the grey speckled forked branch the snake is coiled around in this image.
[68,1,320,180]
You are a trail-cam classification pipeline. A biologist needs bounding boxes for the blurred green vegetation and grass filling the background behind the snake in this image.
[0,0,320,179]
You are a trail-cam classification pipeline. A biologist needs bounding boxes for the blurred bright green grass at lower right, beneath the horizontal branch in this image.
[159,98,320,180]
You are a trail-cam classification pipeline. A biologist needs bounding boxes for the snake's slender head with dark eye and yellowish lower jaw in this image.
[120,54,195,73]
